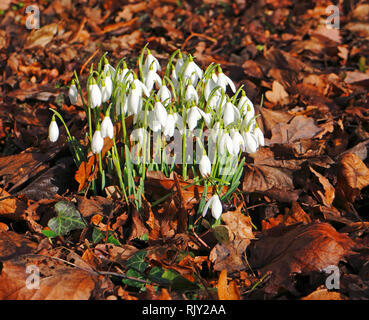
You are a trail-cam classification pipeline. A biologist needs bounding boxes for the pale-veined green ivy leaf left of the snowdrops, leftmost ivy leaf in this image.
[47,201,86,236]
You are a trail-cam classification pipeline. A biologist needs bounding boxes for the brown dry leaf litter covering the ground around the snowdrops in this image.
[0,0,369,300]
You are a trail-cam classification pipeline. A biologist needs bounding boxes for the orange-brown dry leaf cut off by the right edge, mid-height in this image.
[336,153,369,202]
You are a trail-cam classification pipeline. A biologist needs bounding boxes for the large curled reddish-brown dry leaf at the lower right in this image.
[249,223,354,293]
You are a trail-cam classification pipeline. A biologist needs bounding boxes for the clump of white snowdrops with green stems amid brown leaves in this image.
[49,47,264,220]
